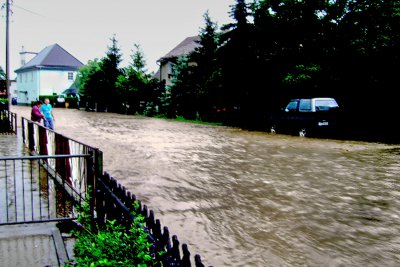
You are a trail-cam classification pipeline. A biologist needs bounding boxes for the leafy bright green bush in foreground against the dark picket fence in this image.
[69,195,161,267]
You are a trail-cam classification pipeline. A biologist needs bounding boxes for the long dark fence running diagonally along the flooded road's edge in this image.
[22,118,209,267]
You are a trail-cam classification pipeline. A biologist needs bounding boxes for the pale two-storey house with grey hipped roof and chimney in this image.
[15,44,83,104]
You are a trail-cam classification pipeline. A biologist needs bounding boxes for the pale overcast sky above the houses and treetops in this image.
[0,0,235,79]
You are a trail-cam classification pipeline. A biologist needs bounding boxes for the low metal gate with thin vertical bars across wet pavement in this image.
[0,155,91,225]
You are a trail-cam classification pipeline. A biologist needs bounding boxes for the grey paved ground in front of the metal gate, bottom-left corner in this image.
[0,223,68,267]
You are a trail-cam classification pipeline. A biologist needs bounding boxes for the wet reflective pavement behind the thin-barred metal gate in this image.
[0,135,73,224]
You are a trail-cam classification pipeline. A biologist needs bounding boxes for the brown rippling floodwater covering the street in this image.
[9,106,400,266]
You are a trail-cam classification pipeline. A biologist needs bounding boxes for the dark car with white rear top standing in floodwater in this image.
[269,97,339,137]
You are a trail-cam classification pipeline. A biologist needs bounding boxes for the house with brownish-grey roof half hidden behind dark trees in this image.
[154,36,201,85]
